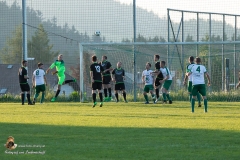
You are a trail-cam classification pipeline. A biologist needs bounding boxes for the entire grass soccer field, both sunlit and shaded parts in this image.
[0,102,240,160]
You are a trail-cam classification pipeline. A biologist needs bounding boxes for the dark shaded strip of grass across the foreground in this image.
[0,123,240,160]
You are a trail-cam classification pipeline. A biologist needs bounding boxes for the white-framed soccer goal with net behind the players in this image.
[79,41,240,102]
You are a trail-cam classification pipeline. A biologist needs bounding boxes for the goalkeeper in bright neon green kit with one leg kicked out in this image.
[46,54,76,102]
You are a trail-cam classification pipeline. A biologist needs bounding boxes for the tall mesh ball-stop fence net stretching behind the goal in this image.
[0,0,240,101]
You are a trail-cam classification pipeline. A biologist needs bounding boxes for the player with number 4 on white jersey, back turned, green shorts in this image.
[186,57,211,112]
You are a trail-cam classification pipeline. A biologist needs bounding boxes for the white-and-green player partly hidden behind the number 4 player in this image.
[183,56,201,107]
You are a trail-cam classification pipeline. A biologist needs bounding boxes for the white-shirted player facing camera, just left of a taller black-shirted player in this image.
[142,62,156,104]
